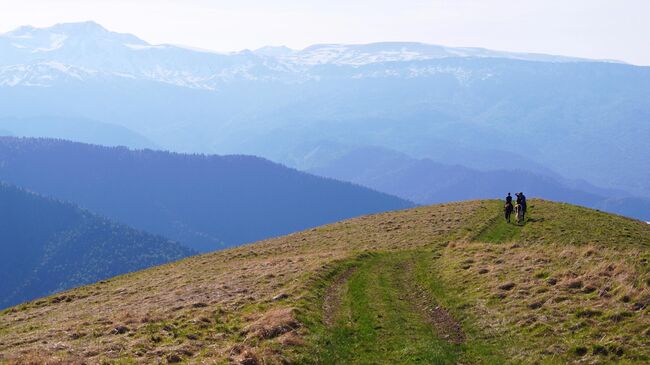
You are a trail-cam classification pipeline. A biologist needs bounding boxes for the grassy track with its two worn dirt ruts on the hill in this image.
[322,252,465,364]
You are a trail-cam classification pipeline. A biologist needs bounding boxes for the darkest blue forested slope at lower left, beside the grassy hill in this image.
[0,184,193,308]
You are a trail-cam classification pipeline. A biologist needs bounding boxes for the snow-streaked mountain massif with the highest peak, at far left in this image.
[0,22,294,89]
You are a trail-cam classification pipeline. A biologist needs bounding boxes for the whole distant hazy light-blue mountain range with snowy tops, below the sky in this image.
[0,22,650,215]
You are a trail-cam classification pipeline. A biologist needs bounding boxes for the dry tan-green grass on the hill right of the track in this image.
[439,201,650,363]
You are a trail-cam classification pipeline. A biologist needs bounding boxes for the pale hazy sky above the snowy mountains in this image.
[0,0,650,65]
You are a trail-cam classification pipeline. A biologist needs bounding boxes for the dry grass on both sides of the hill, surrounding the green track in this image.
[0,200,650,365]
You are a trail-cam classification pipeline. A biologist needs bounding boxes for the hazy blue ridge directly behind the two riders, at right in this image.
[308,148,650,221]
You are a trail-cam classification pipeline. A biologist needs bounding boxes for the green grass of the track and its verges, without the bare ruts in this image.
[301,251,504,364]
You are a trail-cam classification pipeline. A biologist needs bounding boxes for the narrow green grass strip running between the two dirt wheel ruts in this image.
[322,254,460,364]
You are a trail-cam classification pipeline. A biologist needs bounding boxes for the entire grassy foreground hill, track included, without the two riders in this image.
[0,200,650,365]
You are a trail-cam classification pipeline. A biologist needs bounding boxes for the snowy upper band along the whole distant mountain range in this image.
[0,22,616,89]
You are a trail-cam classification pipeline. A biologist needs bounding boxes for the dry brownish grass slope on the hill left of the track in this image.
[0,202,482,364]
